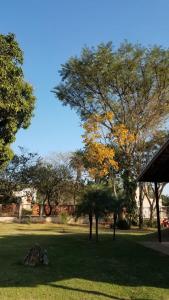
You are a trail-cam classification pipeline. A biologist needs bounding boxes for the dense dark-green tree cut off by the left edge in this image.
[0,34,35,168]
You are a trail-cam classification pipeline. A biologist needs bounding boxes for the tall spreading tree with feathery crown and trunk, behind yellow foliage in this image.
[54,42,169,227]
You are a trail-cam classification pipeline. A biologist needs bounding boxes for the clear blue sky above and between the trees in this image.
[0,0,169,155]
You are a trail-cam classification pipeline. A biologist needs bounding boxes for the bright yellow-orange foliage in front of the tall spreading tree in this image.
[83,111,135,185]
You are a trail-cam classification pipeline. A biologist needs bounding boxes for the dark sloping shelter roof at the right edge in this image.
[137,139,169,182]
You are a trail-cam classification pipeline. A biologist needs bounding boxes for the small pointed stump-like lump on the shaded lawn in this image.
[24,244,49,267]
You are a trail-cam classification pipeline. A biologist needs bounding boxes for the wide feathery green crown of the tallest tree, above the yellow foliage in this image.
[54,42,169,130]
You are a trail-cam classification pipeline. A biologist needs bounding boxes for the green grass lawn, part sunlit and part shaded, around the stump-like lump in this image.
[0,224,169,300]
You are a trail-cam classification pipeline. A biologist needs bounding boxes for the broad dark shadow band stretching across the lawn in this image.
[0,230,169,299]
